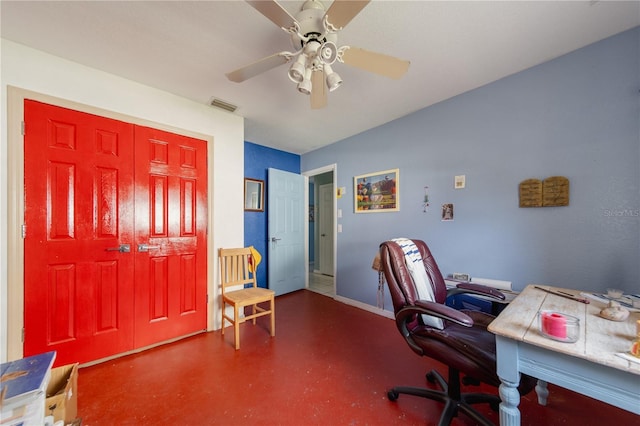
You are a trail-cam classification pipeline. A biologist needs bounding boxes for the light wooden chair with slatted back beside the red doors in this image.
[218,247,276,350]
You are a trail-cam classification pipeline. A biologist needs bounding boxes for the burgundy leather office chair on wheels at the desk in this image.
[380,240,536,425]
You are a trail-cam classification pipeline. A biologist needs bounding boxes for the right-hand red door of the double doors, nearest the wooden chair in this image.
[135,126,207,348]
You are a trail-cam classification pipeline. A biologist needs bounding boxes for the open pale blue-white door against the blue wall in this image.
[267,169,308,296]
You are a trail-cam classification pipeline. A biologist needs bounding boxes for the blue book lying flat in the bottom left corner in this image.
[0,351,56,407]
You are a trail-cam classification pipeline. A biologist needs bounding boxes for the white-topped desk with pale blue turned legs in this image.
[489,285,640,426]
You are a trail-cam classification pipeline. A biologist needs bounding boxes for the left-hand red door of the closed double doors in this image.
[24,101,134,365]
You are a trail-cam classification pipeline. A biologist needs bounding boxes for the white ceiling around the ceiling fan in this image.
[0,0,640,154]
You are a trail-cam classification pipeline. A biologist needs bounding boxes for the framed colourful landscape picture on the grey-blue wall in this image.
[353,169,400,213]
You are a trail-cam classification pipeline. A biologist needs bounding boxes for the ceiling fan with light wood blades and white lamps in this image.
[226,0,409,109]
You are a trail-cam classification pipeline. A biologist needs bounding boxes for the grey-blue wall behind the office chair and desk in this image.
[301,28,640,306]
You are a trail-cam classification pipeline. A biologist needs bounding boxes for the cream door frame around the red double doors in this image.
[6,86,219,363]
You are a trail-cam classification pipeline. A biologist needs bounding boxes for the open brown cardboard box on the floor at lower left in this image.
[44,363,78,425]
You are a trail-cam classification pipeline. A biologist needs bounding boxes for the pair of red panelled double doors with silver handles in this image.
[24,101,207,365]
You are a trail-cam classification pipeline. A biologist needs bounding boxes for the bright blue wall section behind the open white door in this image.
[244,142,300,287]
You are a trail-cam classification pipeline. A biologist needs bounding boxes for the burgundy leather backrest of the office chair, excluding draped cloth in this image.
[380,240,447,313]
